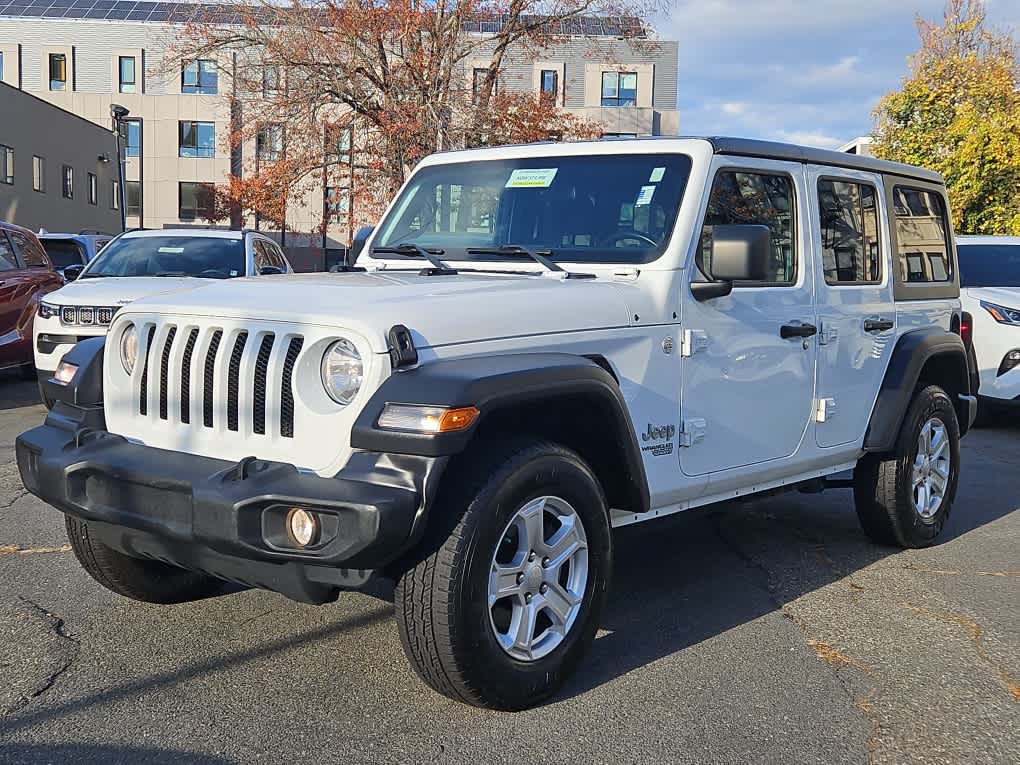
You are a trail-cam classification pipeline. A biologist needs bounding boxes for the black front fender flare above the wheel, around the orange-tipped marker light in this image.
[351,353,649,509]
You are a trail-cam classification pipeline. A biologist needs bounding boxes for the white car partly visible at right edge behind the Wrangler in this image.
[957,237,1020,414]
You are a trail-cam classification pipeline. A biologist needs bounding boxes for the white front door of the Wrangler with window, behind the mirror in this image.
[679,159,817,475]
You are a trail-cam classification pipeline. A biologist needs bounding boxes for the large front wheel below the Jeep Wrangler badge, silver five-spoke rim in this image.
[395,443,612,710]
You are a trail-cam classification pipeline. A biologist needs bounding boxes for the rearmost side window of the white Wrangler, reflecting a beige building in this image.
[893,186,953,284]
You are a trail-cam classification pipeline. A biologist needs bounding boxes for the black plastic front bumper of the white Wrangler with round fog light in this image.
[16,402,442,603]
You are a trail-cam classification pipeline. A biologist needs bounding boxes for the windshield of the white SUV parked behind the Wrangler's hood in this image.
[82,237,245,278]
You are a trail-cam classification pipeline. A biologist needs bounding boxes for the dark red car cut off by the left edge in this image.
[0,220,63,377]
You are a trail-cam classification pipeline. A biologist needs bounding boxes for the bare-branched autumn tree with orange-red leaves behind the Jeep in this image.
[164,0,658,238]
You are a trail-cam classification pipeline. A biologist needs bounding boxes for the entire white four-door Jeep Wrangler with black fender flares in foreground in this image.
[17,138,976,709]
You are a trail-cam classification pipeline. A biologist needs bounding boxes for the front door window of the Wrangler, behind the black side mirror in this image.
[698,170,797,287]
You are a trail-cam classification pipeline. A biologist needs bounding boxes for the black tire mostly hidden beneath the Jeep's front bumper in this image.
[64,515,225,604]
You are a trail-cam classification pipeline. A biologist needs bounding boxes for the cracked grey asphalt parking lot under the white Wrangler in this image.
[0,376,1020,765]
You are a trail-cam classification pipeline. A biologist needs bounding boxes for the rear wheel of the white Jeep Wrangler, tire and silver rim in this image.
[854,386,960,548]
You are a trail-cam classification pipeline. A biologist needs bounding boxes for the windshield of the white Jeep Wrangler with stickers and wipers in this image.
[372,154,691,263]
